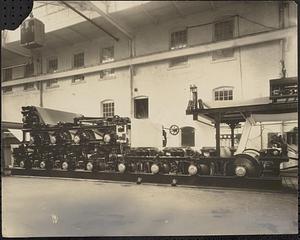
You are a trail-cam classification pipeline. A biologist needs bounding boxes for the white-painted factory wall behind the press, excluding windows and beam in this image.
[2,2,297,148]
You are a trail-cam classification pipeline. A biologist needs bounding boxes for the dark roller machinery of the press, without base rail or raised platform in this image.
[13,106,288,182]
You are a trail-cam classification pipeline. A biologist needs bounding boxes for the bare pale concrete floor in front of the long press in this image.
[2,176,298,237]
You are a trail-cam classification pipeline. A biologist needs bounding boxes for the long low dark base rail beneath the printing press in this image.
[11,168,282,190]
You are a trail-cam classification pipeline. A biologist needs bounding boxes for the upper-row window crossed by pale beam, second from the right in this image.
[170,30,188,67]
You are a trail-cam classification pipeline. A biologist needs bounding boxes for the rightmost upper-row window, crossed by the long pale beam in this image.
[212,18,234,61]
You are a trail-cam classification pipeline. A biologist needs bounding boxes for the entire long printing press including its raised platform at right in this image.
[9,77,297,187]
